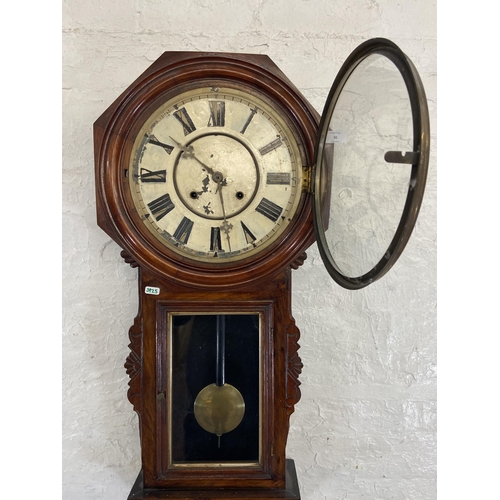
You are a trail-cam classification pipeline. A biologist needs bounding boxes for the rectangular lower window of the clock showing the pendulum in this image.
[169,313,261,465]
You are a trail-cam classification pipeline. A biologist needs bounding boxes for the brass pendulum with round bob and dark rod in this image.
[194,315,245,448]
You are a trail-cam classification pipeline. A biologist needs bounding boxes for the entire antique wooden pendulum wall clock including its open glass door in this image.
[94,39,429,499]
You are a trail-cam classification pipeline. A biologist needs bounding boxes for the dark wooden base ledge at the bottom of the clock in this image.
[128,459,300,500]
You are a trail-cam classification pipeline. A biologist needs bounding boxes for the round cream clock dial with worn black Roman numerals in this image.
[128,87,302,262]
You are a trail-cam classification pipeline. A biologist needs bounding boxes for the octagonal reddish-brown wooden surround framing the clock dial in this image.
[94,52,319,288]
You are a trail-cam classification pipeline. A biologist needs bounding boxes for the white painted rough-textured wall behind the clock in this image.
[63,0,436,500]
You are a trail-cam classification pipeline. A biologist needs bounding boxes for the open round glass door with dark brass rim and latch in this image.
[313,38,429,289]
